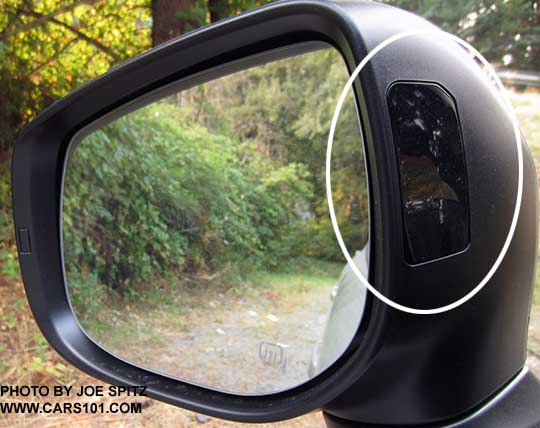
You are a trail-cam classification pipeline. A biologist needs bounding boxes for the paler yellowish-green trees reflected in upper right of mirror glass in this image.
[197,49,369,261]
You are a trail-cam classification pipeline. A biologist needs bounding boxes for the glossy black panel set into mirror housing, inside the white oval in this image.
[387,82,469,264]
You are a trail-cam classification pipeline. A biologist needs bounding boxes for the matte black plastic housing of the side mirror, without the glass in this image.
[13,0,538,425]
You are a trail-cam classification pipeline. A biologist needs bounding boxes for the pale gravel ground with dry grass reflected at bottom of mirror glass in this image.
[95,284,335,393]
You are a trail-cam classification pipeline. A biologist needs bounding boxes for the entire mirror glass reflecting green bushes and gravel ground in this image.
[62,49,369,394]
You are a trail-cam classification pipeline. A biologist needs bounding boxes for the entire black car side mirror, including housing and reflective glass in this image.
[13,0,540,427]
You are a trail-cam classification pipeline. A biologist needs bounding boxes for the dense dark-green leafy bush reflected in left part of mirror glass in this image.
[63,102,311,290]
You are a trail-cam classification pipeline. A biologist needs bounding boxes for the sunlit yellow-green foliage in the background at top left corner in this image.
[0,0,151,150]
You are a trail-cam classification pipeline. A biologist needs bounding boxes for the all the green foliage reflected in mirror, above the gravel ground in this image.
[63,50,369,300]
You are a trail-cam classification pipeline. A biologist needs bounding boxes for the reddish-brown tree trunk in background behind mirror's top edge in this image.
[152,0,200,46]
